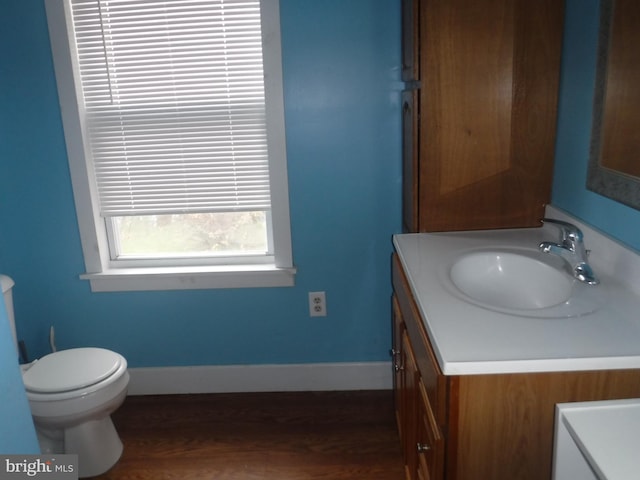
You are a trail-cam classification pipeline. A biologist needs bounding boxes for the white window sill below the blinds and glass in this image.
[80,265,296,292]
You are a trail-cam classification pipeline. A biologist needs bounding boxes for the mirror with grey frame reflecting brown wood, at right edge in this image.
[587,0,640,209]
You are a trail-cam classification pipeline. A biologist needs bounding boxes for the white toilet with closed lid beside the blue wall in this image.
[0,275,129,477]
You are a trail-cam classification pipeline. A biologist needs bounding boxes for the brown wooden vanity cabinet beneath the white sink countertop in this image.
[393,256,640,480]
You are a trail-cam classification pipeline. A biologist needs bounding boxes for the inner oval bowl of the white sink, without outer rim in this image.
[451,251,573,310]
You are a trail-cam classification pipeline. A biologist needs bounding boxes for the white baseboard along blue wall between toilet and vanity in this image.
[128,362,393,395]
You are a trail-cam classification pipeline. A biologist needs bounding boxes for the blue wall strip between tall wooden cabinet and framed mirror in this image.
[552,0,640,250]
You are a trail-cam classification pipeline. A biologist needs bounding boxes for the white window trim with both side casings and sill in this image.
[45,0,296,292]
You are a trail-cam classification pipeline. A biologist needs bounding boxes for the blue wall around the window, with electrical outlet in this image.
[0,0,402,367]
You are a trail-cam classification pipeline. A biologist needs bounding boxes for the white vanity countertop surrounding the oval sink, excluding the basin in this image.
[394,214,640,375]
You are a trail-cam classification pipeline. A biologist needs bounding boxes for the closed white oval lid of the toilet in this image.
[22,348,122,393]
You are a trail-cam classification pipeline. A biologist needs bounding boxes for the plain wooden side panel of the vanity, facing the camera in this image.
[455,370,640,480]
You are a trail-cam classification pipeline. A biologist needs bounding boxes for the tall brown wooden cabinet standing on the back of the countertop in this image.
[402,0,563,232]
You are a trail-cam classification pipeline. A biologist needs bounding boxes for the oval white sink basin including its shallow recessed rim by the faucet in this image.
[448,249,604,318]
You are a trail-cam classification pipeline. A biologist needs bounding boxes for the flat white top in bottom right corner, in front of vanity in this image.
[556,399,640,480]
